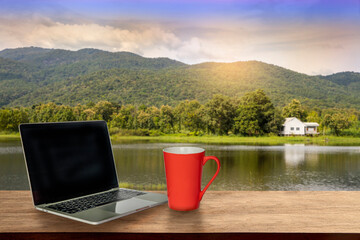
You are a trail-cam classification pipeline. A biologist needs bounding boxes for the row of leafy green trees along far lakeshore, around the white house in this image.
[0,89,360,137]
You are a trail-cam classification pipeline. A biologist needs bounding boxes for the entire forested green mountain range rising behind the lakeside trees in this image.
[0,47,360,109]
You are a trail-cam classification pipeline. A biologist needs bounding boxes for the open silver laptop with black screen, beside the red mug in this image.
[19,121,167,225]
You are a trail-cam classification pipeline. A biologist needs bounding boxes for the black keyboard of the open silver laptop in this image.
[48,189,145,214]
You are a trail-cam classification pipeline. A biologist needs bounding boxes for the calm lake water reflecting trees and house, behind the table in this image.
[0,141,360,191]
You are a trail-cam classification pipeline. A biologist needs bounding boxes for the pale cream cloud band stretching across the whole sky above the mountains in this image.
[0,14,360,74]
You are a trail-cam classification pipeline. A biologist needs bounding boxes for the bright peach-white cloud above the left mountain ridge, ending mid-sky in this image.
[0,17,180,54]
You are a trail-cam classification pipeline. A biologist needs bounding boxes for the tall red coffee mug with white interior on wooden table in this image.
[163,147,220,211]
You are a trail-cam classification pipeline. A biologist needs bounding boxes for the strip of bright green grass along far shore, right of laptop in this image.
[111,135,360,145]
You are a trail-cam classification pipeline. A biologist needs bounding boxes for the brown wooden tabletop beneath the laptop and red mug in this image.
[0,191,360,239]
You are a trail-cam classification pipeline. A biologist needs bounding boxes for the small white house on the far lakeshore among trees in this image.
[280,117,319,136]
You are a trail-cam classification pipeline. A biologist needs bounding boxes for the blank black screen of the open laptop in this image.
[20,121,118,205]
